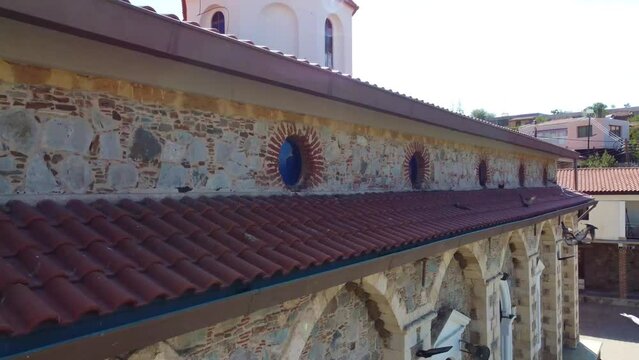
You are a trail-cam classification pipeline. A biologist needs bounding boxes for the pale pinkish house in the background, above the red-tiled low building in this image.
[519,117,630,154]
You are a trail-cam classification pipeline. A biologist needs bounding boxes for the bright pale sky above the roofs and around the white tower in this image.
[132,0,639,115]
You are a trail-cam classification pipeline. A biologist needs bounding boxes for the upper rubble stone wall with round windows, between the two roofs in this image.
[0,60,555,194]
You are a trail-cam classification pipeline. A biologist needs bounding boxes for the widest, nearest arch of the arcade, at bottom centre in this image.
[282,274,405,360]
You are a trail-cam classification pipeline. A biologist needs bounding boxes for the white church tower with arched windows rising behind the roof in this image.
[187,0,353,74]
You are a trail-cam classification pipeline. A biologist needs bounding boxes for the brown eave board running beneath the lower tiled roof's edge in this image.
[6,199,597,360]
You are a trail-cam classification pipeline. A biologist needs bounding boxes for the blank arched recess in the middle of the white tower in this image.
[255,3,299,55]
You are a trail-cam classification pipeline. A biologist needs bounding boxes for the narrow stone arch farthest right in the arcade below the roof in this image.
[537,219,563,359]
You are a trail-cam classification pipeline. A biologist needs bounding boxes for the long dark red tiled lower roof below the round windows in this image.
[0,187,590,337]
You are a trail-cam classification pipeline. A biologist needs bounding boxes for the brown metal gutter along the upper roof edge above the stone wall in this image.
[0,0,578,159]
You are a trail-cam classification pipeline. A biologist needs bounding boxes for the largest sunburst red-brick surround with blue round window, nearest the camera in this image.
[265,123,324,191]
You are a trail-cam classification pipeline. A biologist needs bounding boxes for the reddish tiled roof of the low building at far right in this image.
[557,167,639,193]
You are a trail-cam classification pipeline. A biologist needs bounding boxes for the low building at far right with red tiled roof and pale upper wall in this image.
[557,168,639,298]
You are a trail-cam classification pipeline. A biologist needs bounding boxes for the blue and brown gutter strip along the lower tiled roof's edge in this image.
[6,200,596,360]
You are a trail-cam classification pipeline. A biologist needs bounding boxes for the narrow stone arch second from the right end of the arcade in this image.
[502,231,534,359]
